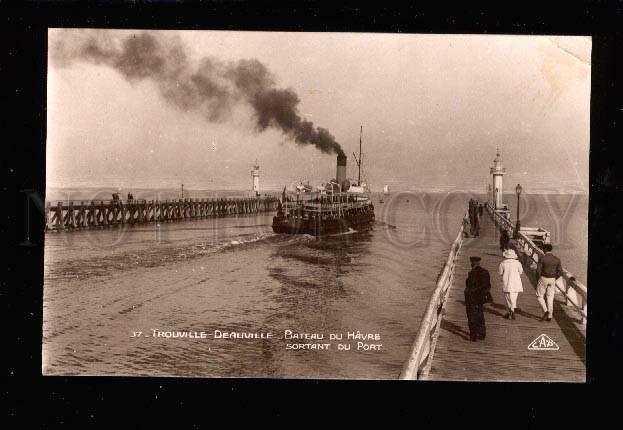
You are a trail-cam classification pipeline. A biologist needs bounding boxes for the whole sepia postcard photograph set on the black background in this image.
[41,28,592,383]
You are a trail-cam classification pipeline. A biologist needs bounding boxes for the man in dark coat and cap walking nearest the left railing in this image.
[465,257,491,342]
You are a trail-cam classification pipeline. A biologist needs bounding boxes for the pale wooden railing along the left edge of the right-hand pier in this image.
[400,214,467,379]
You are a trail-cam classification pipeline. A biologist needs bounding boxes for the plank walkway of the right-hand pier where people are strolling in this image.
[400,203,587,382]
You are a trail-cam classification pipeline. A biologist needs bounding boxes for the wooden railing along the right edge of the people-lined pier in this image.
[487,205,588,325]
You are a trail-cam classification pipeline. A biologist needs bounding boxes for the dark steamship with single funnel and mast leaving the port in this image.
[273,127,374,236]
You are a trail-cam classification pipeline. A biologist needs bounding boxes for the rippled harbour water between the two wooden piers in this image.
[43,194,588,378]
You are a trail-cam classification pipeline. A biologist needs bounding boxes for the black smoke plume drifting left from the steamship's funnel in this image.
[50,30,344,155]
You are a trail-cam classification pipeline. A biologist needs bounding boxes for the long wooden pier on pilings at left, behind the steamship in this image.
[45,197,279,231]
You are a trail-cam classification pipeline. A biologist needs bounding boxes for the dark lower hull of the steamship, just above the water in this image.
[273,210,374,236]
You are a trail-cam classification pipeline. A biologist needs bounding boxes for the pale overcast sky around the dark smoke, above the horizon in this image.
[47,30,591,192]
